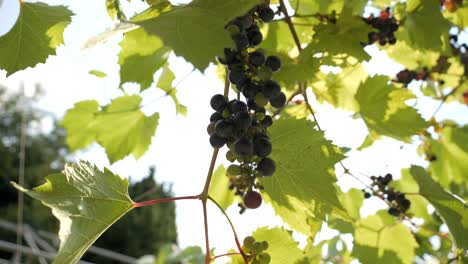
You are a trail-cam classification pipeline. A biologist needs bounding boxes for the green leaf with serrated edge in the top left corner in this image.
[0,1,73,76]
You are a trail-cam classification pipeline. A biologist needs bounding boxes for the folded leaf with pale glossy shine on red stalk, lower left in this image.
[13,161,132,264]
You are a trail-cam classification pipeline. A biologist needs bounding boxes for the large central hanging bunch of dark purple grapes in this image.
[208,5,286,213]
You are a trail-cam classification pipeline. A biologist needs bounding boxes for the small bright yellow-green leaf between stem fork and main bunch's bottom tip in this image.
[208,165,234,210]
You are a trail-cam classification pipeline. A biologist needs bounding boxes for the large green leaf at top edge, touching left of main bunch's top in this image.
[138,0,262,71]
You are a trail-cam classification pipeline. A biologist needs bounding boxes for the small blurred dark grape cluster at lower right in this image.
[363,173,411,216]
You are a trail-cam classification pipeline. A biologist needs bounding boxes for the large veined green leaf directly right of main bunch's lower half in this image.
[264,118,349,234]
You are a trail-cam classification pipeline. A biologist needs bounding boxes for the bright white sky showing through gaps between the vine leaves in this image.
[0,0,468,262]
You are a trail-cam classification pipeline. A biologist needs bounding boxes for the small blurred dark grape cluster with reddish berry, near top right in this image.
[364,8,399,46]
